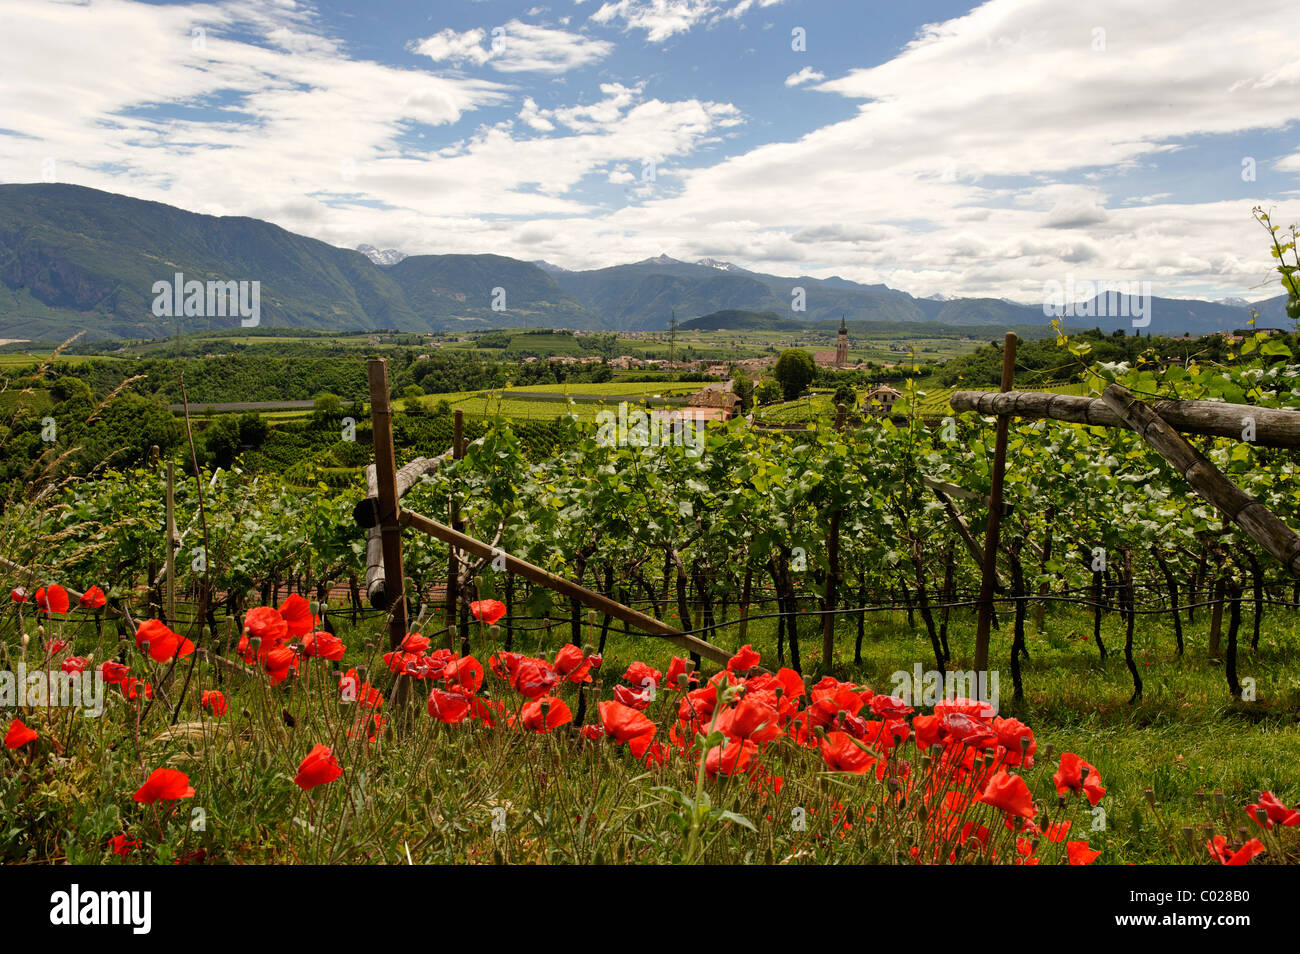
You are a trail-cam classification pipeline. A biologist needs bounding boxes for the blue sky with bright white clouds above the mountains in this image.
[0,0,1300,302]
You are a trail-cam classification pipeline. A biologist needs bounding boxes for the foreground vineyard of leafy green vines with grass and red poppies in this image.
[0,315,1300,863]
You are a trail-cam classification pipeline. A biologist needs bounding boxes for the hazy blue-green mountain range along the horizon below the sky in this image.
[0,183,1286,341]
